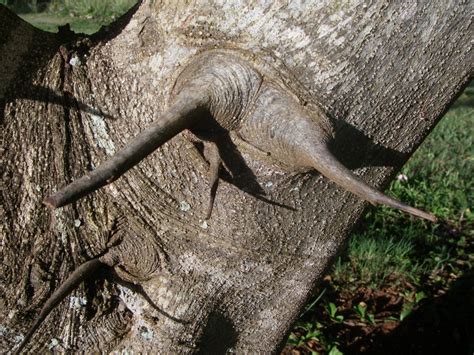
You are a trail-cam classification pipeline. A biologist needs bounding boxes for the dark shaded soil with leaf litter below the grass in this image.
[282,221,474,355]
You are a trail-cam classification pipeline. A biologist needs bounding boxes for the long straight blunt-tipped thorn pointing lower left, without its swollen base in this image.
[43,94,205,208]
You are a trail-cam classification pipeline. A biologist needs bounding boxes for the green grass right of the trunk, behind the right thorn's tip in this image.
[334,87,474,288]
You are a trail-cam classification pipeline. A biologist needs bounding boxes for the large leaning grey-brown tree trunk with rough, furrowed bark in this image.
[0,1,473,353]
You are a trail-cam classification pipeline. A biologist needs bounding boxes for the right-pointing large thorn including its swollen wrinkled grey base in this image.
[240,83,436,222]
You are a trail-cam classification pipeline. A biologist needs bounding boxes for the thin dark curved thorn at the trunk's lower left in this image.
[14,258,105,354]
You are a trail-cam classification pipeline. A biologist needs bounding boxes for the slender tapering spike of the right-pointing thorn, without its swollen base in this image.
[310,145,437,222]
